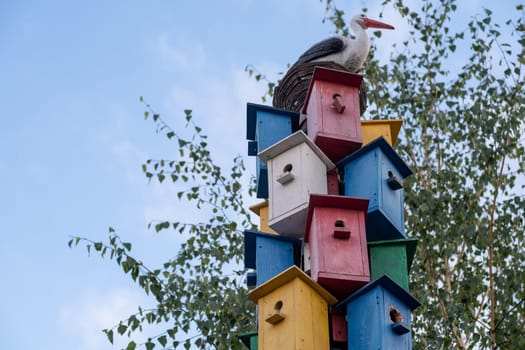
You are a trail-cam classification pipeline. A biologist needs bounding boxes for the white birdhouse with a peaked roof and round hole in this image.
[259,131,334,237]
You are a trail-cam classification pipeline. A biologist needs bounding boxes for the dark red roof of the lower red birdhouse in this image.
[304,194,369,242]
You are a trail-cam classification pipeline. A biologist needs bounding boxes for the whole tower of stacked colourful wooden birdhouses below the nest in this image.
[241,68,419,350]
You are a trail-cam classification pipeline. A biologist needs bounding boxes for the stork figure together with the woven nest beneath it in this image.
[273,14,394,114]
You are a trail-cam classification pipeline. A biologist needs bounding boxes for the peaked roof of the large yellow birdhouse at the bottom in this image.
[248,266,337,305]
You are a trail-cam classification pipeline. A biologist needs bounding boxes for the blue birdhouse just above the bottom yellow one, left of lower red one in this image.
[244,231,302,286]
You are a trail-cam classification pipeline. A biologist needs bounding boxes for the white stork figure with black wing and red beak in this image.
[294,14,394,73]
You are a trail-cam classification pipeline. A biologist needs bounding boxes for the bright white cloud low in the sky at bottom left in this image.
[59,289,144,350]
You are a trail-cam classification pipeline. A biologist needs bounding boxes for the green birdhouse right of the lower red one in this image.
[368,239,417,291]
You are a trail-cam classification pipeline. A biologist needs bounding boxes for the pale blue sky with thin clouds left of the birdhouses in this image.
[0,0,516,350]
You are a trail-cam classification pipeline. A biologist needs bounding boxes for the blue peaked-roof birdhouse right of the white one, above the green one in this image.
[337,137,412,241]
